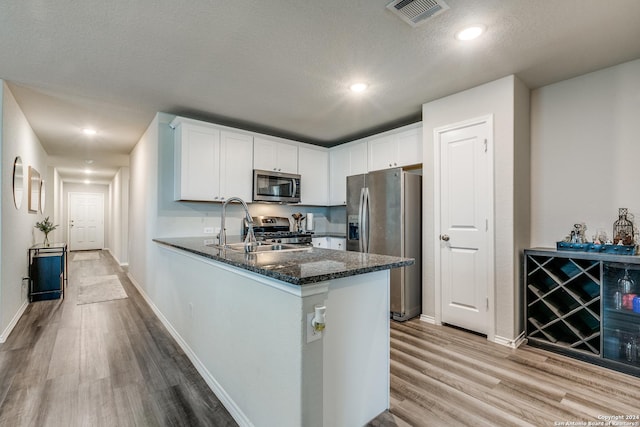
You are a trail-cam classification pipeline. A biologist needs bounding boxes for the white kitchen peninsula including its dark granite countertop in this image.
[154,238,414,426]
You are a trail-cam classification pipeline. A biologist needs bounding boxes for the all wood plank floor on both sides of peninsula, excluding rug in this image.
[5,251,640,427]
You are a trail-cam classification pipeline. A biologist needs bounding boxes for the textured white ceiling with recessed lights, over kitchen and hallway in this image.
[0,0,640,182]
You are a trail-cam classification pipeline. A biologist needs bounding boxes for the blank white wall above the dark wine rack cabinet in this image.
[531,60,640,247]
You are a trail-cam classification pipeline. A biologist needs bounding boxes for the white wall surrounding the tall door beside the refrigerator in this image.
[422,76,529,341]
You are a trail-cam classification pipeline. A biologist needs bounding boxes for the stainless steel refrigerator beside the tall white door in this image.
[347,168,422,321]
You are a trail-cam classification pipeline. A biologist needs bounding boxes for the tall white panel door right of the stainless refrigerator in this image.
[436,119,493,334]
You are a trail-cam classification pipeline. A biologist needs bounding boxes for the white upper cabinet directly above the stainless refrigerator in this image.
[368,123,422,171]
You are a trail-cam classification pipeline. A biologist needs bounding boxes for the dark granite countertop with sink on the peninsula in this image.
[153,237,415,285]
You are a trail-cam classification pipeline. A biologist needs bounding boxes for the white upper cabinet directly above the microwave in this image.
[253,137,298,173]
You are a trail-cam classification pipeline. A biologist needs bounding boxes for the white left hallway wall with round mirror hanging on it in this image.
[0,80,49,342]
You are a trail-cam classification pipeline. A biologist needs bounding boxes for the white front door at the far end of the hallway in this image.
[69,193,104,251]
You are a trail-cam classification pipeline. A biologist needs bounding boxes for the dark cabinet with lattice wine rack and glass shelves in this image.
[524,249,640,376]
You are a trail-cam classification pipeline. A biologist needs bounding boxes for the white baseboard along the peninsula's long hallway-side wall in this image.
[127,273,253,427]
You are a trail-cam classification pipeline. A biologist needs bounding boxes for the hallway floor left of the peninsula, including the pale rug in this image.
[0,251,236,426]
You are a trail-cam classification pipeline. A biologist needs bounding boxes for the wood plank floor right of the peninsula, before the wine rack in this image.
[390,319,640,426]
